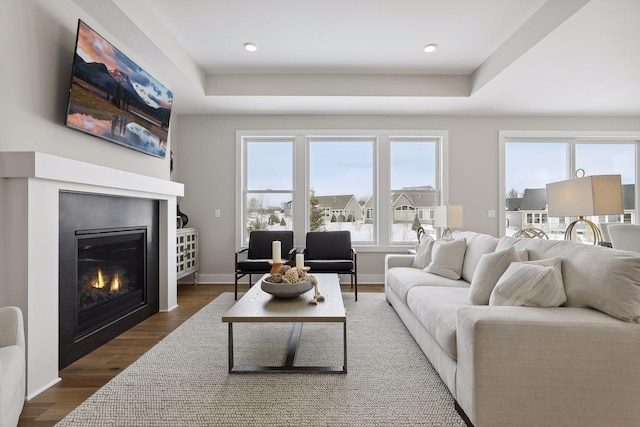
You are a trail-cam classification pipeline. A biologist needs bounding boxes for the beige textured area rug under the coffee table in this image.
[58,293,465,427]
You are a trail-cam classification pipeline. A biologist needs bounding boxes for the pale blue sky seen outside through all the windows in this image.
[247,141,636,206]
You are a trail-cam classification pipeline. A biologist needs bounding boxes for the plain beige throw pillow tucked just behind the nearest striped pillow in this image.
[469,246,521,305]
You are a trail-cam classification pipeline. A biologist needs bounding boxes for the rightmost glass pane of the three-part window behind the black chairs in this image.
[390,139,440,242]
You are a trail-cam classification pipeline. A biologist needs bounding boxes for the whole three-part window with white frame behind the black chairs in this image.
[236,131,447,252]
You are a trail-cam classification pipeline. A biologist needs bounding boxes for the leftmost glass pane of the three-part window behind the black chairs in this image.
[242,139,293,243]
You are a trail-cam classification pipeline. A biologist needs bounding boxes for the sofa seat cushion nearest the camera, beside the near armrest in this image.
[407,286,471,360]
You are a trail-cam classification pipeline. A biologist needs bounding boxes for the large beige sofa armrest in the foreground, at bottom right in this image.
[456,306,640,427]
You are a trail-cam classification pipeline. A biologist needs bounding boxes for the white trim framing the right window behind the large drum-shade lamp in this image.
[498,130,640,237]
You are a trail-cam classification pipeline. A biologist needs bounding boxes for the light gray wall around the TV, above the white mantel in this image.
[0,0,169,179]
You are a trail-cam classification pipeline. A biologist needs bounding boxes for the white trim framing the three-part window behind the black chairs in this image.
[235,129,449,252]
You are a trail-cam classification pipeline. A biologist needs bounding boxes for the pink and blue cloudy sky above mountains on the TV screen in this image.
[76,21,173,109]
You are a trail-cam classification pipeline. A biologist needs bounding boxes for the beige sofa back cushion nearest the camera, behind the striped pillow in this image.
[497,237,640,323]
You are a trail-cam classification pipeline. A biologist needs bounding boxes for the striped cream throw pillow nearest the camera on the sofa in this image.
[489,257,567,307]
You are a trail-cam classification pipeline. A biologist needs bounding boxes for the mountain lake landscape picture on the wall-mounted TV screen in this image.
[66,21,173,158]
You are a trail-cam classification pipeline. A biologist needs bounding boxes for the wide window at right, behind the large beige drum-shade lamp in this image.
[501,135,638,243]
